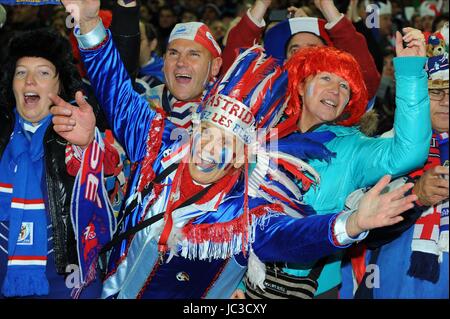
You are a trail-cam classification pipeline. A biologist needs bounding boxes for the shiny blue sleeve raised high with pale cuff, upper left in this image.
[75,23,156,162]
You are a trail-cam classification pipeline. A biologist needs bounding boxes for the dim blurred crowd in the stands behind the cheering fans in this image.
[0,0,448,135]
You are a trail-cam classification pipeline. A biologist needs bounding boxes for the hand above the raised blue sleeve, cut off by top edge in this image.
[61,0,100,34]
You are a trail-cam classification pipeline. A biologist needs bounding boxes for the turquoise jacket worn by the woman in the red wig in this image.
[285,57,432,294]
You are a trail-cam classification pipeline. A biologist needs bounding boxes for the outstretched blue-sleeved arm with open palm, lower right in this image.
[253,176,417,263]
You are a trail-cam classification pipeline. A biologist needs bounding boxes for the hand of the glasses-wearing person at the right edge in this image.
[413,166,448,206]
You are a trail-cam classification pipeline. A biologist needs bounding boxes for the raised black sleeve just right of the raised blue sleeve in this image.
[111,1,141,84]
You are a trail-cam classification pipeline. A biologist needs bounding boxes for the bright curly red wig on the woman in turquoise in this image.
[285,47,368,126]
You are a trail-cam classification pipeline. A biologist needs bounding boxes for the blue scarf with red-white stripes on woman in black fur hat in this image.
[0,111,51,297]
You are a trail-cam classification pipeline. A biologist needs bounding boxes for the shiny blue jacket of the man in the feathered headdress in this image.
[81,33,352,298]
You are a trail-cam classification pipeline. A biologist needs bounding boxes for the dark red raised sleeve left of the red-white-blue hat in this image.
[220,13,264,74]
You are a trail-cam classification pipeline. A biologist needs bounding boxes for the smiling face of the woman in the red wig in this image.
[298,72,351,132]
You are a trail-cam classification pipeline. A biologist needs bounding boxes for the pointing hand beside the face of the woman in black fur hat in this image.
[49,91,95,149]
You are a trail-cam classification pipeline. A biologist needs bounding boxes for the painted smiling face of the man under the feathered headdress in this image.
[189,123,244,185]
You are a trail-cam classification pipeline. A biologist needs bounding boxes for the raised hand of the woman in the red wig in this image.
[395,28,427,57]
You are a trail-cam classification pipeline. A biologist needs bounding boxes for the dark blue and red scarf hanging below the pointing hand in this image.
[71,129,117,298]
